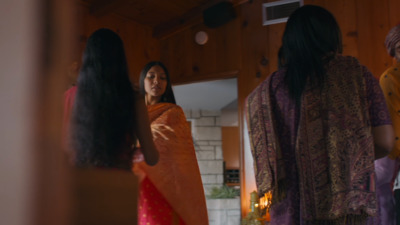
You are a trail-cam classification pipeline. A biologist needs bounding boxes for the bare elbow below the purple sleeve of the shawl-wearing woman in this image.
[372,125,394,159]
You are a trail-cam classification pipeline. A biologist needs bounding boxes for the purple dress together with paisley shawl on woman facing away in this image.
[246,55,390,224]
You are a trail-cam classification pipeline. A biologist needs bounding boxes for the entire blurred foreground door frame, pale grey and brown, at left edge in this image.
[0,0,74,225]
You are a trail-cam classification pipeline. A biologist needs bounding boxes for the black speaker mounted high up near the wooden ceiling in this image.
[203,2,236,28]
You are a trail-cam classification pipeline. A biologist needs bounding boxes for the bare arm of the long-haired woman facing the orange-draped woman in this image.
[134,91,159,166]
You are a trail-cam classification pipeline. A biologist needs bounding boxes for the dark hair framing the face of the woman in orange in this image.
[139,61,176,104]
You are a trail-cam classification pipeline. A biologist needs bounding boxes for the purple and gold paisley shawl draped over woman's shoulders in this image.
[246,56,377,224]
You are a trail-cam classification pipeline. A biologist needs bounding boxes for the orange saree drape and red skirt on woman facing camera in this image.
[134,103,208,225]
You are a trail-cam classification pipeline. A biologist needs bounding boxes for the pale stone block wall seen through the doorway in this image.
[184,110,241,225]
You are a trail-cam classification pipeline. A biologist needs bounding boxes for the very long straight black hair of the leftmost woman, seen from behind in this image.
[71,28,135,167]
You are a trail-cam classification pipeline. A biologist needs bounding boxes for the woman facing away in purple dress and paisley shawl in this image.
[246,5,394,225]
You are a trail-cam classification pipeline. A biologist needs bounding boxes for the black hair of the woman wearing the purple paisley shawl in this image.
[279,5,342,102]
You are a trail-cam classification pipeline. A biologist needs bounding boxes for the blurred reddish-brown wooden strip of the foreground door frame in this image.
[33,0,75,225]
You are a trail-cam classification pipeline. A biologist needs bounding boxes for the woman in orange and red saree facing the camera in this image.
[134,62,208,225]
